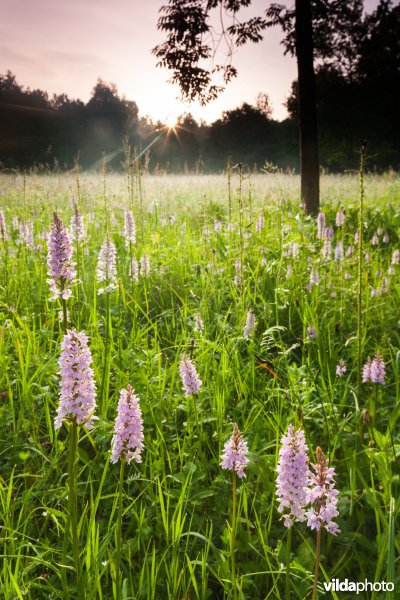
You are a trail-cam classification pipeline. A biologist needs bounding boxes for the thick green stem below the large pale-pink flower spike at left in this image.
[68,422,85,599]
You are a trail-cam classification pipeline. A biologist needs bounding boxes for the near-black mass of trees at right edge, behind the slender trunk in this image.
[286,0,400,171]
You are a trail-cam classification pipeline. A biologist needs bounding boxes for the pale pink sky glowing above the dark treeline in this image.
[0,0,378,123]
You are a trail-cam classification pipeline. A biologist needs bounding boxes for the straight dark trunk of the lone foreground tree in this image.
[295,0,319,214]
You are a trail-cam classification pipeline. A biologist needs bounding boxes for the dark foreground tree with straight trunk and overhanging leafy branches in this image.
[153,0,378,213]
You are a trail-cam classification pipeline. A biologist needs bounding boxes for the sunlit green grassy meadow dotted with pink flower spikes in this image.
[0,171,400,600]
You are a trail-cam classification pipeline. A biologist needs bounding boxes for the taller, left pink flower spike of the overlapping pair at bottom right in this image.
[276,425,308,527]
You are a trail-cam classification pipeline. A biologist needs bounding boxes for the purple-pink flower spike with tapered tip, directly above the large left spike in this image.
[47,213,76,300]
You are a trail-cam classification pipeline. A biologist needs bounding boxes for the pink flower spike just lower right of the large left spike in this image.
[110,385,144,465]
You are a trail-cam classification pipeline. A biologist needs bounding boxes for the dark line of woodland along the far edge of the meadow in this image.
[0,3,400,173]
